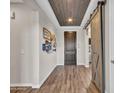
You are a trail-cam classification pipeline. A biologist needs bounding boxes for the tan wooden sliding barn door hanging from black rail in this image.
[91,3,103,93]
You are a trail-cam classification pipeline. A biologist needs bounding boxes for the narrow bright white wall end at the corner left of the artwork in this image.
[30,11,40,88]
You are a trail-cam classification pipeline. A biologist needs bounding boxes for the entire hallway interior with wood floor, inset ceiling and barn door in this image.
[10,0,114,93]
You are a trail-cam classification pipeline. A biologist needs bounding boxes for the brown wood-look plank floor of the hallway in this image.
[10,66,98,93]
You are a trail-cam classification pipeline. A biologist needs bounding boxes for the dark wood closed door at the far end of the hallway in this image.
[64,32,76,65]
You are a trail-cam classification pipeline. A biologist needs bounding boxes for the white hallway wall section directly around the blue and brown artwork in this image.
[39,8,57,85]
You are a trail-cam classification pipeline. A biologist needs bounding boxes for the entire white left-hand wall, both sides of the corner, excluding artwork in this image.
[10,0,57,88]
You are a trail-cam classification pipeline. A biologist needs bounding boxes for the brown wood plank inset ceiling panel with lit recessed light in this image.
[49,0,90,26]
